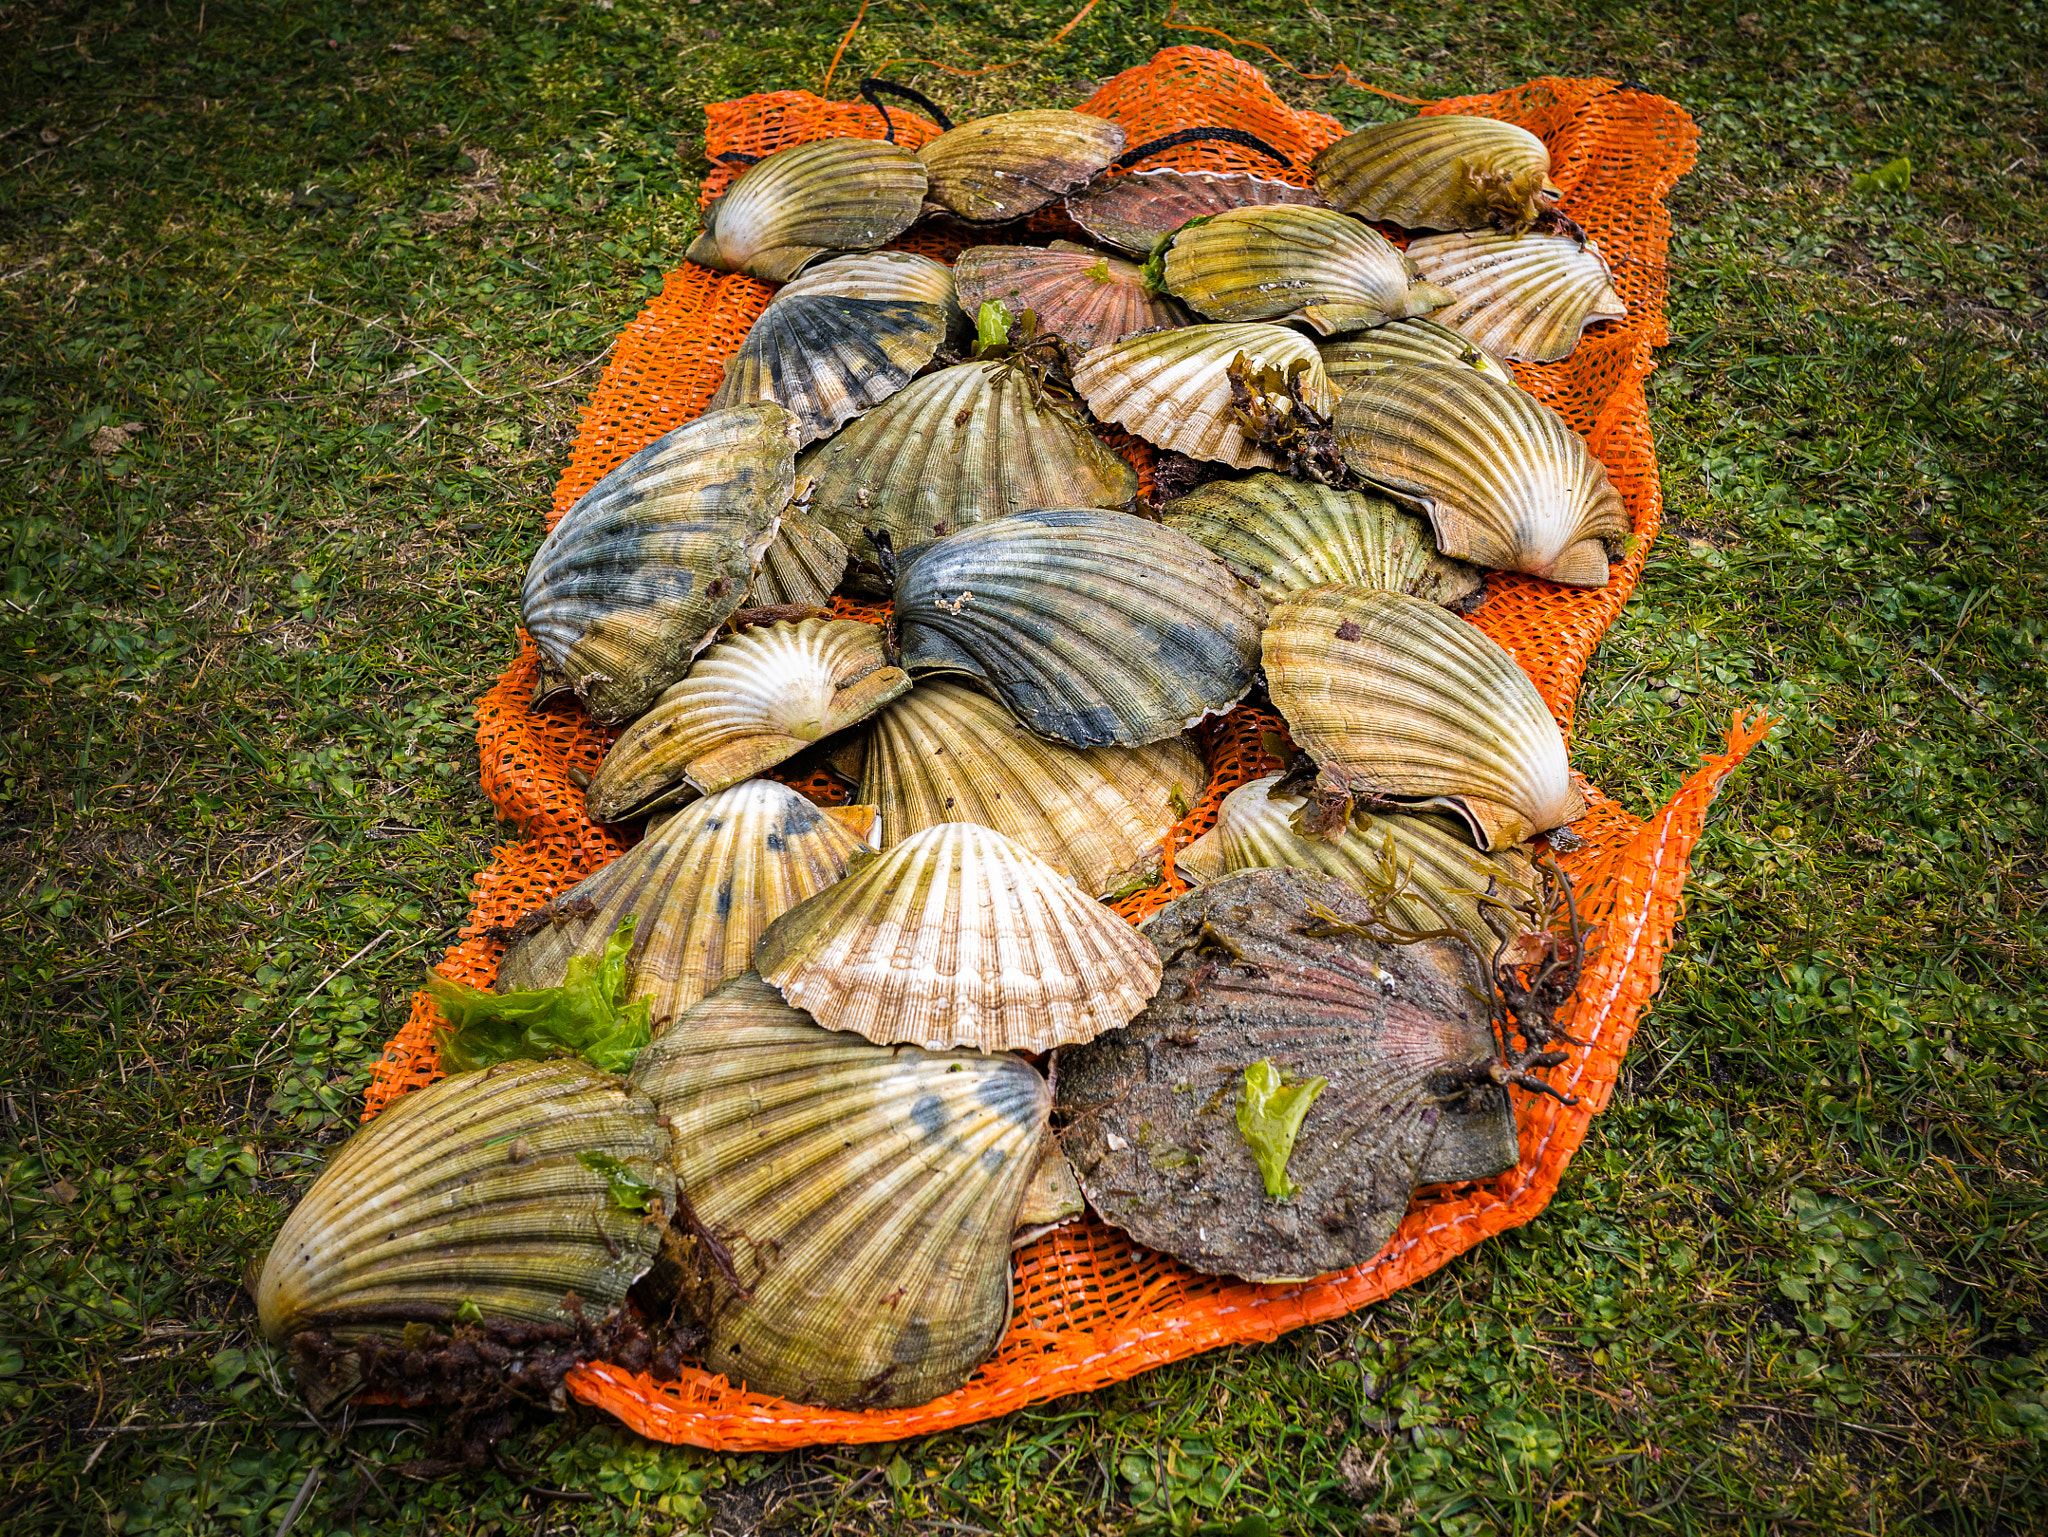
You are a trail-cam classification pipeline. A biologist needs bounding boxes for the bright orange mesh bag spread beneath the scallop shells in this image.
[365,47,1767,1451]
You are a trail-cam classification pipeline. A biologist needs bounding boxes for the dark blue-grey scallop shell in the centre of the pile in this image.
[895,508,1266,748]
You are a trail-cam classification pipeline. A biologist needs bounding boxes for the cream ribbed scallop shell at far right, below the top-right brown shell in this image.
[1409,230,1628,363]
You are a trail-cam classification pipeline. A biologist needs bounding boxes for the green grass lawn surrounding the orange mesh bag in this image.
[0,0,2048,1537]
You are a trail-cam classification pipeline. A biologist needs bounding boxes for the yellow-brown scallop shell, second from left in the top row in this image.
[918,111,1124,223]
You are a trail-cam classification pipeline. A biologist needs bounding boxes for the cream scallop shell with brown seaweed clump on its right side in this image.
[1073,324,1341,469]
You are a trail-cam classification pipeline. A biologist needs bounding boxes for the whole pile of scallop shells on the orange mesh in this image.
[258,111,1628,1408]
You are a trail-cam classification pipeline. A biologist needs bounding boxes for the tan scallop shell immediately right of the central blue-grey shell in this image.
[1266,586,1585,848]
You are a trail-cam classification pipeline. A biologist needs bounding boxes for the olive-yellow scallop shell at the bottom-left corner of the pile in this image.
[256,1062,676,1342]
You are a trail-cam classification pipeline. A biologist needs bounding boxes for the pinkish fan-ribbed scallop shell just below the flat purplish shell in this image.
[952,240,1188,352]
